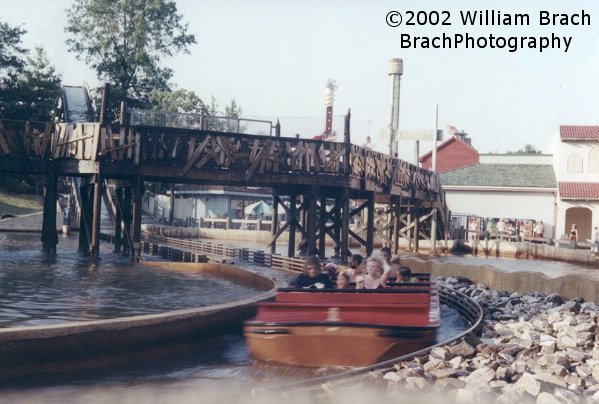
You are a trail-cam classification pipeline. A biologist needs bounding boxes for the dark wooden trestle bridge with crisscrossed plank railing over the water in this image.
[0,87,449,259]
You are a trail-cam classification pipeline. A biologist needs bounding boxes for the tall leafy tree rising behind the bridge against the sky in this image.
[65,0,195,118]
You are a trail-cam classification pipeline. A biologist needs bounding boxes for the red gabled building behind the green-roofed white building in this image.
[420,133,480,173]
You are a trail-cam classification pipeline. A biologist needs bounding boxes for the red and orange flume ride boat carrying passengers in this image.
[244,281,440,367]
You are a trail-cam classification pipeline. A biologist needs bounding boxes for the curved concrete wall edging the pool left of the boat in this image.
[0,262,281,380]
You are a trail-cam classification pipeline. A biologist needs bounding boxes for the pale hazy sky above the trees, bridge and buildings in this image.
[0,0,599,161]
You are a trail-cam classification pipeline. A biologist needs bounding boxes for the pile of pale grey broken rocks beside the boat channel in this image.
[376,277,599,403]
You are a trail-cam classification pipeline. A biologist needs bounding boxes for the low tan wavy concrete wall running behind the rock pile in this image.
[402,258,599,303]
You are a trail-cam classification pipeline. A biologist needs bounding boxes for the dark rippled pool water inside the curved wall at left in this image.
[0,233,260,327]
